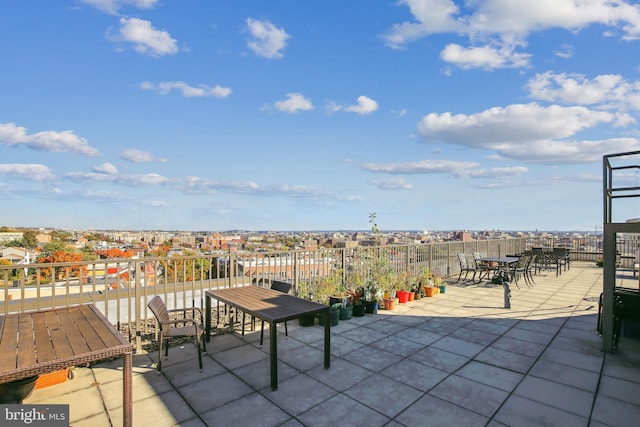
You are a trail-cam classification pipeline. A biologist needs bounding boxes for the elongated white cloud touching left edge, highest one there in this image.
[0,123,99,156]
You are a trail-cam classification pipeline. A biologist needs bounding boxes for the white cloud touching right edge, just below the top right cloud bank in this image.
[526,71,640,110]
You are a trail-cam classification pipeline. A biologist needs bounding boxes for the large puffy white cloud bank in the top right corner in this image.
[383,0,640,68]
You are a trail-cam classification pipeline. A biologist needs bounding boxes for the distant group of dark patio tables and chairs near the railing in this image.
[456,247,571,287]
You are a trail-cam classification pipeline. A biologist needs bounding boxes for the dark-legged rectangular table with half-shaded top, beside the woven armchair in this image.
[205,286,331,390]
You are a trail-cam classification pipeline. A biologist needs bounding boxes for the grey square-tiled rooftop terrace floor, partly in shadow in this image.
[24,262,640,427]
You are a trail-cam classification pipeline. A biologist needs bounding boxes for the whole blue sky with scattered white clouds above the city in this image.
[0,0,640,232]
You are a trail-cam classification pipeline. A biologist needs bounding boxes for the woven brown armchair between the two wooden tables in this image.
[147,295,207,373]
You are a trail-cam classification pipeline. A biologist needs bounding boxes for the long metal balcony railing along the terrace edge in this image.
[0,238,624,352]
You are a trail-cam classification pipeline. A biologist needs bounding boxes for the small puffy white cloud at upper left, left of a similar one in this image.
[113,18,178,56]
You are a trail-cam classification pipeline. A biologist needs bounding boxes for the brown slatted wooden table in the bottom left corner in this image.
[0,304,133,427]
